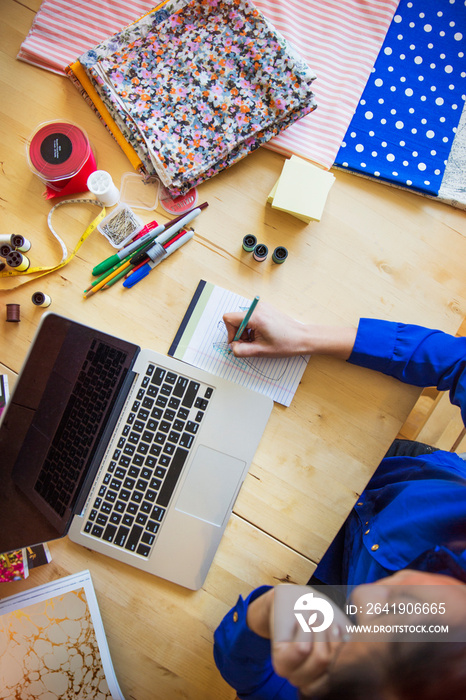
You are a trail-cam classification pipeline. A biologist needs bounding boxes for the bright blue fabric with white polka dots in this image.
[335,0,466,195]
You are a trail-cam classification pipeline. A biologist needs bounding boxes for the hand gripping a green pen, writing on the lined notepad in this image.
[223,302,314,357]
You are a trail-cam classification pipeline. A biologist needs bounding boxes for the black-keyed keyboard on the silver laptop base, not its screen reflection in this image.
[84,364,214,557]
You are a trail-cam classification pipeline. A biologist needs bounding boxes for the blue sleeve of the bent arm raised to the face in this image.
[214,586,297,700]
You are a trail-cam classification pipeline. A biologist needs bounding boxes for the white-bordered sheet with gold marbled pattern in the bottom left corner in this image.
[0,571,125,700]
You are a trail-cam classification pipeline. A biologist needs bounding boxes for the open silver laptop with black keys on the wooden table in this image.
[0,313,273,589]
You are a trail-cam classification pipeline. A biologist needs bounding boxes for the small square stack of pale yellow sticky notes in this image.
[267,156,335,224]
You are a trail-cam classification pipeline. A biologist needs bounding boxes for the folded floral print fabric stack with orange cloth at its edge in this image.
[67,0,316,195]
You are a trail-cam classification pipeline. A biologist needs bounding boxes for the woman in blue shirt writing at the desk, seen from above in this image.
[214,304,466,700]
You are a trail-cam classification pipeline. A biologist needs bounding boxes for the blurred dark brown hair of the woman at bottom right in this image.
[318,628,466,700]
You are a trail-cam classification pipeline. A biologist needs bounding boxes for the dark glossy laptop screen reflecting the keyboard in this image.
[0,314,139,552]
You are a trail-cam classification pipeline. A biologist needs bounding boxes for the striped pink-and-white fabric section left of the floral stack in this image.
[17,0,157,75]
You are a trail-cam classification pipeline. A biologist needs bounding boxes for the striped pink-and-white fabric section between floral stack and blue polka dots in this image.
[254,0,398,168]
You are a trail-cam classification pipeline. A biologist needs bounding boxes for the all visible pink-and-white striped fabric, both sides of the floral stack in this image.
[18,0,399,168]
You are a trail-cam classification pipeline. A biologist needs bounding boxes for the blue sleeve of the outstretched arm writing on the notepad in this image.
[348,318,466,425]
